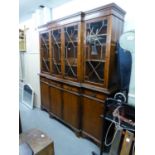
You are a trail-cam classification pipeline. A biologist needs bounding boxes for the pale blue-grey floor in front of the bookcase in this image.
[20,104,107,155]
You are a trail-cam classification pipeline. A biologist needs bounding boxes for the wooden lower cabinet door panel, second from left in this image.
[50,87,62,118]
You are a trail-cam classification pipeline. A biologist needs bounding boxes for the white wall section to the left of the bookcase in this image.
[19,18,41,107]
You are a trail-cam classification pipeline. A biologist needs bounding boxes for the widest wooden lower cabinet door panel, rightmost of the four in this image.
[82,97,104,141]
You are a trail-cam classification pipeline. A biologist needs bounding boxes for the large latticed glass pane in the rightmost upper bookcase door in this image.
[85,20,107,83]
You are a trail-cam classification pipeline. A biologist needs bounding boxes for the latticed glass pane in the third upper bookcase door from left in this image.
[64,25,78,78]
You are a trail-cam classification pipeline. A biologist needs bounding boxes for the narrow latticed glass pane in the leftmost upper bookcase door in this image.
[40,32,50,72]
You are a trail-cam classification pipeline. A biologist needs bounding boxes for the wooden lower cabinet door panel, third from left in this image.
[63,92,80,128]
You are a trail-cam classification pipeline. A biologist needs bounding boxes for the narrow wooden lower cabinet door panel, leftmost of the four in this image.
[40,82,50,111]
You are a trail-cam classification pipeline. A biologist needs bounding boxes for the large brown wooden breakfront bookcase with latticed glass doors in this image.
[39,3,125,144]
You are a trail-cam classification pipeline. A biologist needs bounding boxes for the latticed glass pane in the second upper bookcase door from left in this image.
[51,29,61,75]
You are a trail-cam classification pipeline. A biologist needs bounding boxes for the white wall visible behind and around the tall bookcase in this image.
[19,0,135,106]
